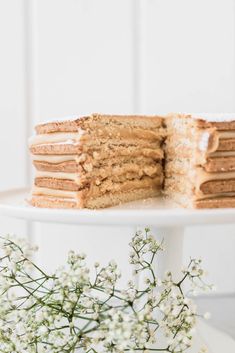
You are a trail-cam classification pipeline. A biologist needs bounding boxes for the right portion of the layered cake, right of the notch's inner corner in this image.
[164,114,235,208]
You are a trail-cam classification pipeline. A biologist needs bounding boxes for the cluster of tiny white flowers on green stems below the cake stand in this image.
[0,229,211,353]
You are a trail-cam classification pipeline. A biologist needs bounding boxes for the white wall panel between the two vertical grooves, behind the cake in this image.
[30,0,138,281]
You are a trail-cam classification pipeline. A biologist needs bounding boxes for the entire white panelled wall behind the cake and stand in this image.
[0,0,235,324]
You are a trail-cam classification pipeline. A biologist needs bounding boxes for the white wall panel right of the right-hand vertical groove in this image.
[139,0,235,292]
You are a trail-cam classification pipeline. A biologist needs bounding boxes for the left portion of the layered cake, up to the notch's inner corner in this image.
[30,114,165,208]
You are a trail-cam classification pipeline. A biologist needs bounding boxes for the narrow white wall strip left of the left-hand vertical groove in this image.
[0,0,27,236]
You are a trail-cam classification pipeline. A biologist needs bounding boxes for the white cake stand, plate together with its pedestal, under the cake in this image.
[0,189,235,275]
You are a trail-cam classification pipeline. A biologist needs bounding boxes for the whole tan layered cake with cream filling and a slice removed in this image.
[30,114,235,209]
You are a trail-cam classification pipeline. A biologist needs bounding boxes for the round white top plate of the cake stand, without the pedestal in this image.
[0,189,235,227]
